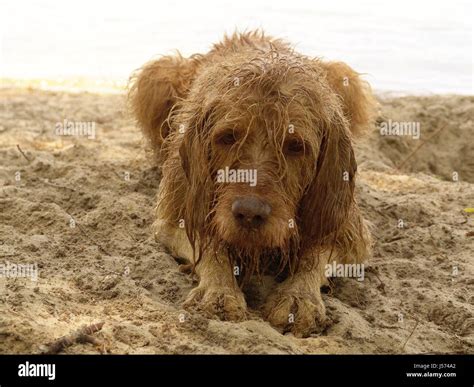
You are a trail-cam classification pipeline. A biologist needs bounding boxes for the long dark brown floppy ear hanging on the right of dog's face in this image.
[298,114,357,255]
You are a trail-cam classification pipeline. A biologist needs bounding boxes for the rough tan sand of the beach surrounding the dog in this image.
[0,87,474,354]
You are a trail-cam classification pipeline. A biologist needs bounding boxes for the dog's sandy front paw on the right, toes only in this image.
[263,291,326,337]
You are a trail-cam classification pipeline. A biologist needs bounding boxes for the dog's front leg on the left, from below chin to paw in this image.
[184,253,247,321]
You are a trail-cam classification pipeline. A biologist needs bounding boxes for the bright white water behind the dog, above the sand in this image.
[0,0,474,94]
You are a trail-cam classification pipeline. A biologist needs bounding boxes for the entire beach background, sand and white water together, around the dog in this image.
[0,0,474,354]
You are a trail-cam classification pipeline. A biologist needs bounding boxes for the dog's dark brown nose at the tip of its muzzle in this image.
[232,196,272,228]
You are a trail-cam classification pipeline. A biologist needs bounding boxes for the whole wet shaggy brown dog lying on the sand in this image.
[129,32,375,336]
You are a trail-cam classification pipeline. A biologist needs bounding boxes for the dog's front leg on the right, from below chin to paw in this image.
[263,253,329,337]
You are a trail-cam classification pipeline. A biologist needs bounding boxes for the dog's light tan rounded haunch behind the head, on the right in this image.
[321,62,377,135]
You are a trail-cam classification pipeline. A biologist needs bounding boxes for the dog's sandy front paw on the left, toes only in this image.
[184,285,247,321]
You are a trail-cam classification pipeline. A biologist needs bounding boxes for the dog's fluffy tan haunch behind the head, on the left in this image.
[128,53,199,153]
